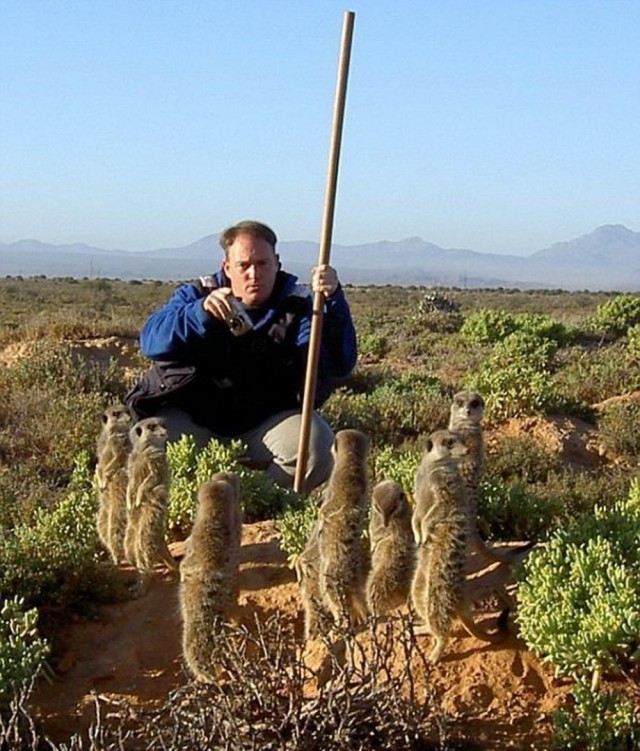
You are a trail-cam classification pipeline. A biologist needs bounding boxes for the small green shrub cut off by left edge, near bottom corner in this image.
[0,597,49,711]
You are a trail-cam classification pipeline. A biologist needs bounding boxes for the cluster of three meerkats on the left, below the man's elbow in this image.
[96,412,242,681]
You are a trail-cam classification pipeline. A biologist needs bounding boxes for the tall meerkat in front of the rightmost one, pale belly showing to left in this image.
[411,430,509,662]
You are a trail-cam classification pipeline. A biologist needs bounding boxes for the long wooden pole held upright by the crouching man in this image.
[293,11,356,494]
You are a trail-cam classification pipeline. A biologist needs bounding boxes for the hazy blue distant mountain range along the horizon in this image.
[0,224,640,291]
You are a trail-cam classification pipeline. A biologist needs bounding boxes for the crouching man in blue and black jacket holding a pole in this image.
[126,221,357,491]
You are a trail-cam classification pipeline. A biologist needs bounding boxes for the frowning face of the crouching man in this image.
[222,234,280,307]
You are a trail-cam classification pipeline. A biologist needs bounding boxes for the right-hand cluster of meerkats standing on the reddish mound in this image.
[296,391,531,662]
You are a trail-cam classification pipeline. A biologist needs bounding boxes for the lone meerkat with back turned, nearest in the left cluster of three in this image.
[180,472,242,681]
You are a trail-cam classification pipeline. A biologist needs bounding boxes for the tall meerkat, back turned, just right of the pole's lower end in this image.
[318,429,369,633]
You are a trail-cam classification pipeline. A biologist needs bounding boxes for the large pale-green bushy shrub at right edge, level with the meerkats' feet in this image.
[517,482,640,688]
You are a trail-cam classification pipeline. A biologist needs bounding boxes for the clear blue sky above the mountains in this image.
[0,0,640,254]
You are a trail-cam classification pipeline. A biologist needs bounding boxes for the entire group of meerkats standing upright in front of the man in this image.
[96,392,530,681]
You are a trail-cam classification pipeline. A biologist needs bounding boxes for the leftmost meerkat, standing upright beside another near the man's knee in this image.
[95,404,131,565]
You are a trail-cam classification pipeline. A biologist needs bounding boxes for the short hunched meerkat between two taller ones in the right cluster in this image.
[366,480,415,616]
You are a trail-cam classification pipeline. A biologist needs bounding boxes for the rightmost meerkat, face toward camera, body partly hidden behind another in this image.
[449,391,534,563]
